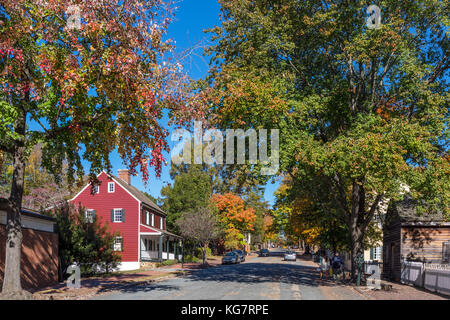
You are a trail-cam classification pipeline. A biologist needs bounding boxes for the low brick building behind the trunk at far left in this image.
[0,208,58,289]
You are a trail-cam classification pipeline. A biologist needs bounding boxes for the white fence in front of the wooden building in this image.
[401,261,450,295]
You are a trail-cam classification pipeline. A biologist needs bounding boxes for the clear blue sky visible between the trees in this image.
[67,0,279,204]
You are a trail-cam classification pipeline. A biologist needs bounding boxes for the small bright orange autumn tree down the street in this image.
[211,193,256,249]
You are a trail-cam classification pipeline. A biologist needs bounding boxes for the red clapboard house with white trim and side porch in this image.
[70,170,182,270]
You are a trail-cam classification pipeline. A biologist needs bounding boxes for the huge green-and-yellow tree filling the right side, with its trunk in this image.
[203,0,450,275]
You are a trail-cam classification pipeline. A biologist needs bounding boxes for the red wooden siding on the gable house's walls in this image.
[72,172,140,262]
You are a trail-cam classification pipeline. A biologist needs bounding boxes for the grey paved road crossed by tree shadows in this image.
[97,252,362,300]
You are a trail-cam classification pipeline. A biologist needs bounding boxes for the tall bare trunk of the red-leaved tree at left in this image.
[2,111,26,294]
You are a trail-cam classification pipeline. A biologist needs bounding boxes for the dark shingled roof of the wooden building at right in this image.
[389,196,446,223]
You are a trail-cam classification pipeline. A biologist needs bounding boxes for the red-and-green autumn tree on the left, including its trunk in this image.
[0,0,200,294]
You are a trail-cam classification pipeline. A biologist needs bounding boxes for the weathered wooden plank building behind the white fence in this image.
[383,197,450,281]
